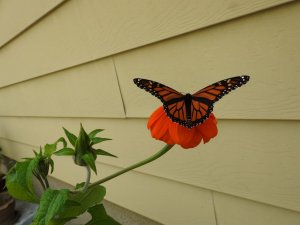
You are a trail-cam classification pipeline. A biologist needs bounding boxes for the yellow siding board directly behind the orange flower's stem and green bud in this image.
[0,117,300,211]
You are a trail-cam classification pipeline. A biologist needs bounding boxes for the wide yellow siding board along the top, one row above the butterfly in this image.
[0,0,291,86]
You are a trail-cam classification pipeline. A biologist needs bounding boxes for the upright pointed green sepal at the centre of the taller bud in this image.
[75,124,90,166]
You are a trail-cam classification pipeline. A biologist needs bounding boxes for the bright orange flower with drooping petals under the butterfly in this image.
[147,106,218,148]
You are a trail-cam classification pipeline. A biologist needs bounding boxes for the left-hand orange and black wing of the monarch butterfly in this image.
[133,78,187,124]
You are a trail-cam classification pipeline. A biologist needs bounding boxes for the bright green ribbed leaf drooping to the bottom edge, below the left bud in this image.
[32,189,69,225]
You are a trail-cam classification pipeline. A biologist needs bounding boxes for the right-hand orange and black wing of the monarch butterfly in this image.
[189,75,250,127]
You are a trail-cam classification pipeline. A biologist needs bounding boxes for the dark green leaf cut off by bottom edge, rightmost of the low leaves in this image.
[86,204,121,225]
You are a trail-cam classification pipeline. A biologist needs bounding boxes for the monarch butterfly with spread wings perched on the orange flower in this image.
[133,75,250,128]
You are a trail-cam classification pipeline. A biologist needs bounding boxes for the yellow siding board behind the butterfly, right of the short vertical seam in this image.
[114,1,300,120]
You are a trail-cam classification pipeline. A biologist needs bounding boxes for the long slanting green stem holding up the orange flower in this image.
[89,145,174,188]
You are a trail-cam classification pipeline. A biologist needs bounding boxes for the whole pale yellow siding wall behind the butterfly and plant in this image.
[0,0,300,225]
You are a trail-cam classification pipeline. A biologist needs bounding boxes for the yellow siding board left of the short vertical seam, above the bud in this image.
[0,58,125,118]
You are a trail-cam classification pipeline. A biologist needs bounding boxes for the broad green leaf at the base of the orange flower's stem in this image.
[57,185,106,219]
